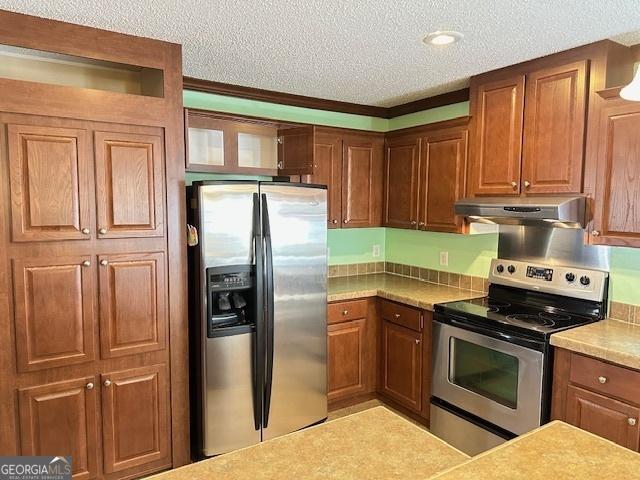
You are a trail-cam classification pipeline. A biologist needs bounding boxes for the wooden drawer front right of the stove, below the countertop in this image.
[569,354,640,404]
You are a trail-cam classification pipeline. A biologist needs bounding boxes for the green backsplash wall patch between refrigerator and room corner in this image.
[327,228,387,265]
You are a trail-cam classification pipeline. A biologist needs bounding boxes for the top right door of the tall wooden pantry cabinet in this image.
[95,132,164,238]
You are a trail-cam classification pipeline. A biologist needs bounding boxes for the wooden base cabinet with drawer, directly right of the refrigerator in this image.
[327,300,377,403]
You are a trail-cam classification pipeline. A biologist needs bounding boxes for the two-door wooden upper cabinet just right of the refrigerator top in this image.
[302,128,383,228]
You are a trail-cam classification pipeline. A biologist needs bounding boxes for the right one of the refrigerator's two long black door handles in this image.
[262,193,274,428]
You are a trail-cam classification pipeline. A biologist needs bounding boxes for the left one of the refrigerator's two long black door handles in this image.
[252,193,265,430]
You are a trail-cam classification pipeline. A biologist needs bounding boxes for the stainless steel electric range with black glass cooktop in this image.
[431,259,608,455]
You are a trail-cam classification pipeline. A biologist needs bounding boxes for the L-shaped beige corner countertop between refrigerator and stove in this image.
[327,273,485,310]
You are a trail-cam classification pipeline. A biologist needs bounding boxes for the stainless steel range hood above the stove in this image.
[455,196,585,228]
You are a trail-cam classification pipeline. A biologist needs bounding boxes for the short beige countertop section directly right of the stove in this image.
[551,319,640,369]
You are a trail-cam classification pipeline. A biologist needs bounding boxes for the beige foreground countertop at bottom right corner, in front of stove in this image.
[433,421,640,480]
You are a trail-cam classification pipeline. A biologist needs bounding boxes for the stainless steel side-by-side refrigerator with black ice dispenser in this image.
[188,181,327,456]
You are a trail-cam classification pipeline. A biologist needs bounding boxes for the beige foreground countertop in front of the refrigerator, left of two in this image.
[153,407,469,480]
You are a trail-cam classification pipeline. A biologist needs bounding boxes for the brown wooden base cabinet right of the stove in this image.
[551,349,640,451]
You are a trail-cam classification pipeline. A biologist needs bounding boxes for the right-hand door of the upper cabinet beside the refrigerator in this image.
[342,137,383,227]
